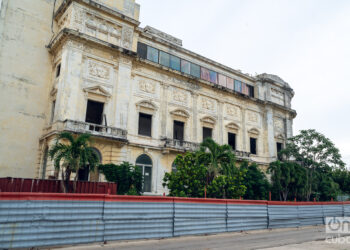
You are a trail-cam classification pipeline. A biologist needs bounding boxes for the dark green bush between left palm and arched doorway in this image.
[99,162,143,195]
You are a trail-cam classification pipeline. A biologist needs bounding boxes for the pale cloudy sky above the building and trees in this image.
[136,0,350,168]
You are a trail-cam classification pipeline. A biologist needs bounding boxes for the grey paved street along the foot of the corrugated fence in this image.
[57,226,350,250]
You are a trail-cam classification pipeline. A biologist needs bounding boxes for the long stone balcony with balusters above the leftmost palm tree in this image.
[45,120,128,142]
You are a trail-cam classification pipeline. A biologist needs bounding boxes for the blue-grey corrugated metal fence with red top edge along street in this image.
[0,193,350,248]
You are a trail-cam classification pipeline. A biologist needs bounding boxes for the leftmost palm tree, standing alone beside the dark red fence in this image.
[49,132,99,193]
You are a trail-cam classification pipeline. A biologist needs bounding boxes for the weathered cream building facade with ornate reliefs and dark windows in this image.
[0,0,296,193]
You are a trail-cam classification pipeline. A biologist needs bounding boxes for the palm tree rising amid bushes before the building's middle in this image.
[199,137,235,188]
